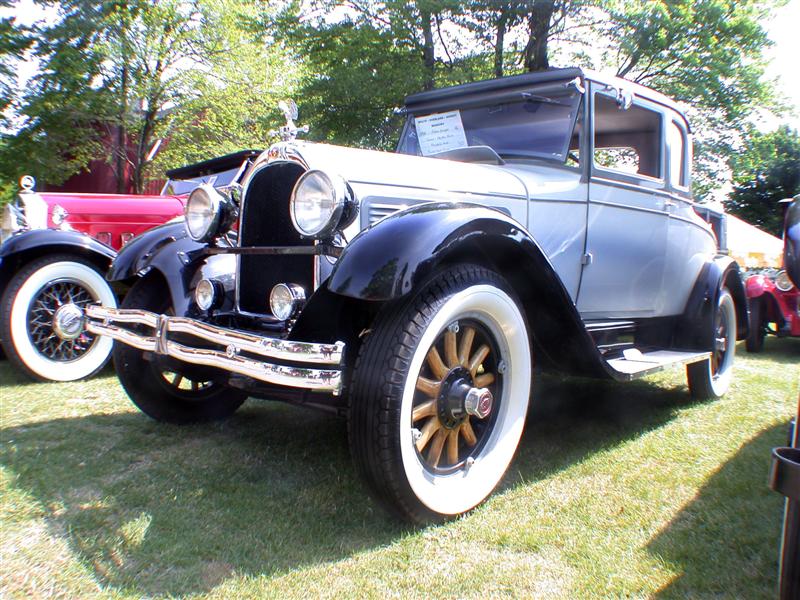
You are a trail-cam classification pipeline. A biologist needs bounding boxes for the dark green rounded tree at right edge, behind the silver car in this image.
[724,126,800,236]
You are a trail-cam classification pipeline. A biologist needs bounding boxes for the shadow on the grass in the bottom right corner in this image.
[648,423,788,598]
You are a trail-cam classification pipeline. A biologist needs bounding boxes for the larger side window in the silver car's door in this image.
[593,94,663,179]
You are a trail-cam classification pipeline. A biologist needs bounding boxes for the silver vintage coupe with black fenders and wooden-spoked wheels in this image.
[78,68,747,522]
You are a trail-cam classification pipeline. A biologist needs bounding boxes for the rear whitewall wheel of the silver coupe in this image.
[686,288,736,400]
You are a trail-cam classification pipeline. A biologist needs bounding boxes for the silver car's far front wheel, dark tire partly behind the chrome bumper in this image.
[114,277,247,425]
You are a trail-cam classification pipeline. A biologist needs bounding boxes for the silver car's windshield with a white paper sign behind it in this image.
[397,92,581,162]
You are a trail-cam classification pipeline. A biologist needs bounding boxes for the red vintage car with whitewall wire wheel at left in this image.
[0,150,259,381]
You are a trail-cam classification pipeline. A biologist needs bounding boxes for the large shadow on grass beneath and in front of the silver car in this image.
[0,356,744,596]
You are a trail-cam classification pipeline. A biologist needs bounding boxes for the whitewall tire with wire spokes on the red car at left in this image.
[0,255,117,381]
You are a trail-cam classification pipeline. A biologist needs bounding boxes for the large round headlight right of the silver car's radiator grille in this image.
[289,171,347,238]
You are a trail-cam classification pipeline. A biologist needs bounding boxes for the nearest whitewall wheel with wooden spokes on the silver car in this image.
[348,265,531,523]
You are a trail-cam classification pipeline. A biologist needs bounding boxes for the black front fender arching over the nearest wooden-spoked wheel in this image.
[324,203,609,377]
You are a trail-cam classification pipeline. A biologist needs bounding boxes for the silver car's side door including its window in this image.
[578,82,670,319]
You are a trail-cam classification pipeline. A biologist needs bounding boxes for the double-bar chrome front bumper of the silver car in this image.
[86,305,344,395]
